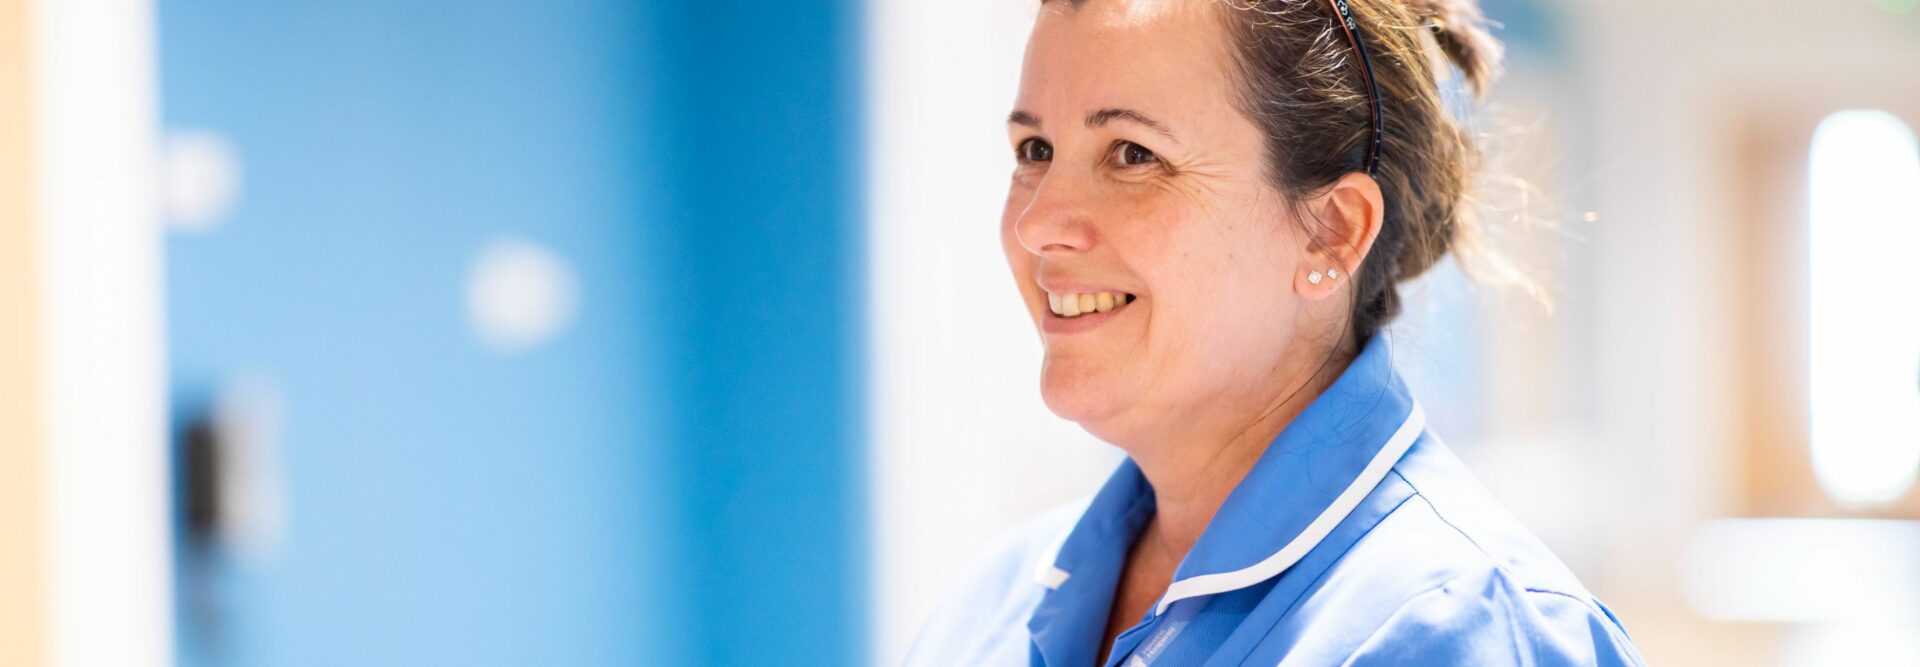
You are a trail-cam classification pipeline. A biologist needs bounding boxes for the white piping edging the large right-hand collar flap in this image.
[1144,404,1427,615]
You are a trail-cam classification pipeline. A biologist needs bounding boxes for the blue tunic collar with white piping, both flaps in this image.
[1027,334,1427,663]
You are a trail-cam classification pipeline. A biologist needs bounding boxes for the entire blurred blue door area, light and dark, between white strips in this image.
[159,0,866,665]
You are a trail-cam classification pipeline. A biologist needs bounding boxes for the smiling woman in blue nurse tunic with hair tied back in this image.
[908,0,1642,667]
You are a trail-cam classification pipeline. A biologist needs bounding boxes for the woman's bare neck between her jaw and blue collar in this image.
[1127,344,1352,563]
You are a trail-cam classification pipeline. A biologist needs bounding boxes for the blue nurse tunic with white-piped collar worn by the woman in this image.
[906,336,1644,667]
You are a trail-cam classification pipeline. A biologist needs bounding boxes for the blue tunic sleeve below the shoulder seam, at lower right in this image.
[1346,569,1645,667]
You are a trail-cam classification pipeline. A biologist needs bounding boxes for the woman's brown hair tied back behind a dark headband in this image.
[1221,0,1501,346]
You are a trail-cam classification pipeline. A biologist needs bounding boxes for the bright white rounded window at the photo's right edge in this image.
[1807,111,1920,506]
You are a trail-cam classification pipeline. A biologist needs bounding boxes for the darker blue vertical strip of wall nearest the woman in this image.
[660,2,866,665]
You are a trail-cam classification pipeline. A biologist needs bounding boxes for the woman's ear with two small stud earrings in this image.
[1294,171,1386,300]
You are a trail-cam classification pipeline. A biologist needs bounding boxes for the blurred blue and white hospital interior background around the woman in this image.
[0,0,1920,665]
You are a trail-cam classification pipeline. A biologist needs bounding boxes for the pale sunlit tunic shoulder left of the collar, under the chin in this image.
[906,500,1087,665]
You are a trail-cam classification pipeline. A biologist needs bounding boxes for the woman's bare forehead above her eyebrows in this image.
[1020,0,1231,120]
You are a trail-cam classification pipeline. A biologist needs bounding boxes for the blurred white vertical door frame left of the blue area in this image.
[27,0,173,667]
